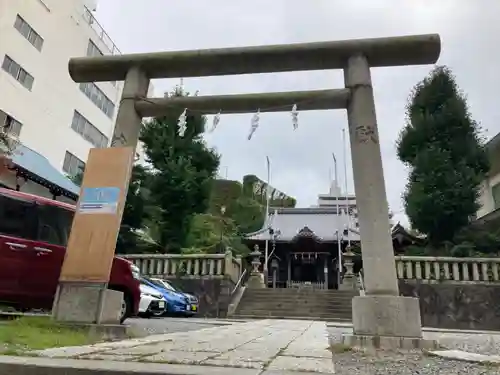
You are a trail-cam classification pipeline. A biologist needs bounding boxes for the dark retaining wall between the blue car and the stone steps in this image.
[165,277,235,318]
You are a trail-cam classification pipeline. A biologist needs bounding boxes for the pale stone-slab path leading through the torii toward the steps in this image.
[36,320,334,373]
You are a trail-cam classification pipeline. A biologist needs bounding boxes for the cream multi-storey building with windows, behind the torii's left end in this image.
[0,0,148,203]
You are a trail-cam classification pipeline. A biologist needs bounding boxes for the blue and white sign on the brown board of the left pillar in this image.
[78,187,120,214]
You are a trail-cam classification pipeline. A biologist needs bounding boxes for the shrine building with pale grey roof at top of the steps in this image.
[245,183,422,289]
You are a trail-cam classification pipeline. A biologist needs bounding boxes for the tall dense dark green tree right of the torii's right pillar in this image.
[397,67,489,247]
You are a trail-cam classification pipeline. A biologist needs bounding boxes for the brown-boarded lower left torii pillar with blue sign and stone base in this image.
[53,147,135,323]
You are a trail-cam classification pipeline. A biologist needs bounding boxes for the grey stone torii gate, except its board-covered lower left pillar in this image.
[69,34,441,347]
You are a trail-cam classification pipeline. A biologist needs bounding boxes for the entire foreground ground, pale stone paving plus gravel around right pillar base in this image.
[13,320,500,375]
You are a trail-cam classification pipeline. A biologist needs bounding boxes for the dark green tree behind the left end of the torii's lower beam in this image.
[141,90,219,252]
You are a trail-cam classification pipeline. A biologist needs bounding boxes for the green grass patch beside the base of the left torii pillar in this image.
[0,317,99,355]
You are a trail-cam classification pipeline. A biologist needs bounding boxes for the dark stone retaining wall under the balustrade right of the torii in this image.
[399,280,500,331]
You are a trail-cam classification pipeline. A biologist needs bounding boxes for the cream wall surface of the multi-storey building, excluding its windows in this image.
[0,0,148,178]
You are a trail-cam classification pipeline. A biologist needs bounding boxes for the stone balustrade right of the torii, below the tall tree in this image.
[395,256,500,283]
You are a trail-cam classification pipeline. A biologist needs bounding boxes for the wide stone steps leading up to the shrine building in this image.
[235,288,356,321]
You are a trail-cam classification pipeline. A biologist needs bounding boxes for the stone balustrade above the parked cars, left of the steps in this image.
[119,251,243,283]
